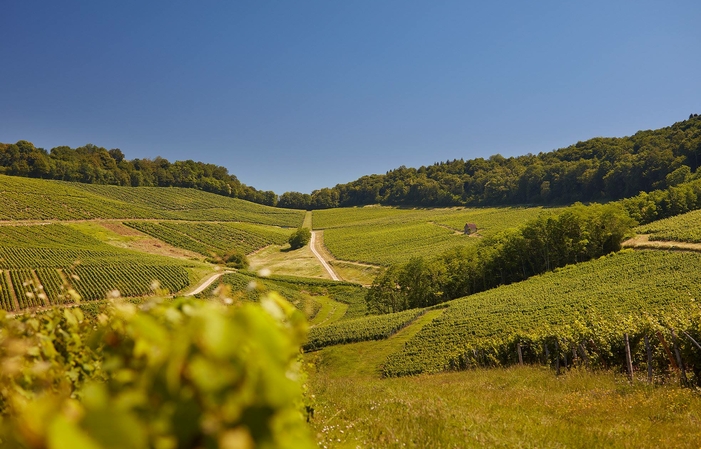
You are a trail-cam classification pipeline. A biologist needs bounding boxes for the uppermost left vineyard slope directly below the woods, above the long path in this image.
[0,175,304,227]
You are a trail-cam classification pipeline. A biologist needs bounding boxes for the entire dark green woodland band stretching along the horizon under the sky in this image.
[0,114,701,209]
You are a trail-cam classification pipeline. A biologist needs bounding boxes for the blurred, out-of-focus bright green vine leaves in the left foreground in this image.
[0,295,312,449]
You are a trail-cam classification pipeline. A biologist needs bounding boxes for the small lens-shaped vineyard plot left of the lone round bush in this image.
[125,221,290,256]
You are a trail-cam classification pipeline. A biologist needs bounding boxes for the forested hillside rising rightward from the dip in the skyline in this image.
[278,114,701,208]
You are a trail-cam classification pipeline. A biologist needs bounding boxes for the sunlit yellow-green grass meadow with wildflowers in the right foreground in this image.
[310,367,701,449]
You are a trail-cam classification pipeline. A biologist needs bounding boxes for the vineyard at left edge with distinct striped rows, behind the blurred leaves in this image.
[0,224,194,311]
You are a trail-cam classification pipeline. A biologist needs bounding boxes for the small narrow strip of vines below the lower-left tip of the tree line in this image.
[304,310,424,351]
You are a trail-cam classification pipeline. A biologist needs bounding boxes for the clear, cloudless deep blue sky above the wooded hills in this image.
[0,0,701,193]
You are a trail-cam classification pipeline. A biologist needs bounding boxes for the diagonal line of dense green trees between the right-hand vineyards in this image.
[366,204,636,313]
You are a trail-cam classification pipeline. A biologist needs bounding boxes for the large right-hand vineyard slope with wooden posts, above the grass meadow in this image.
[385,251,701,376]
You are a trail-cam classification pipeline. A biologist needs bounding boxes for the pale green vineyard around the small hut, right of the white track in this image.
[313,207,558,265]
